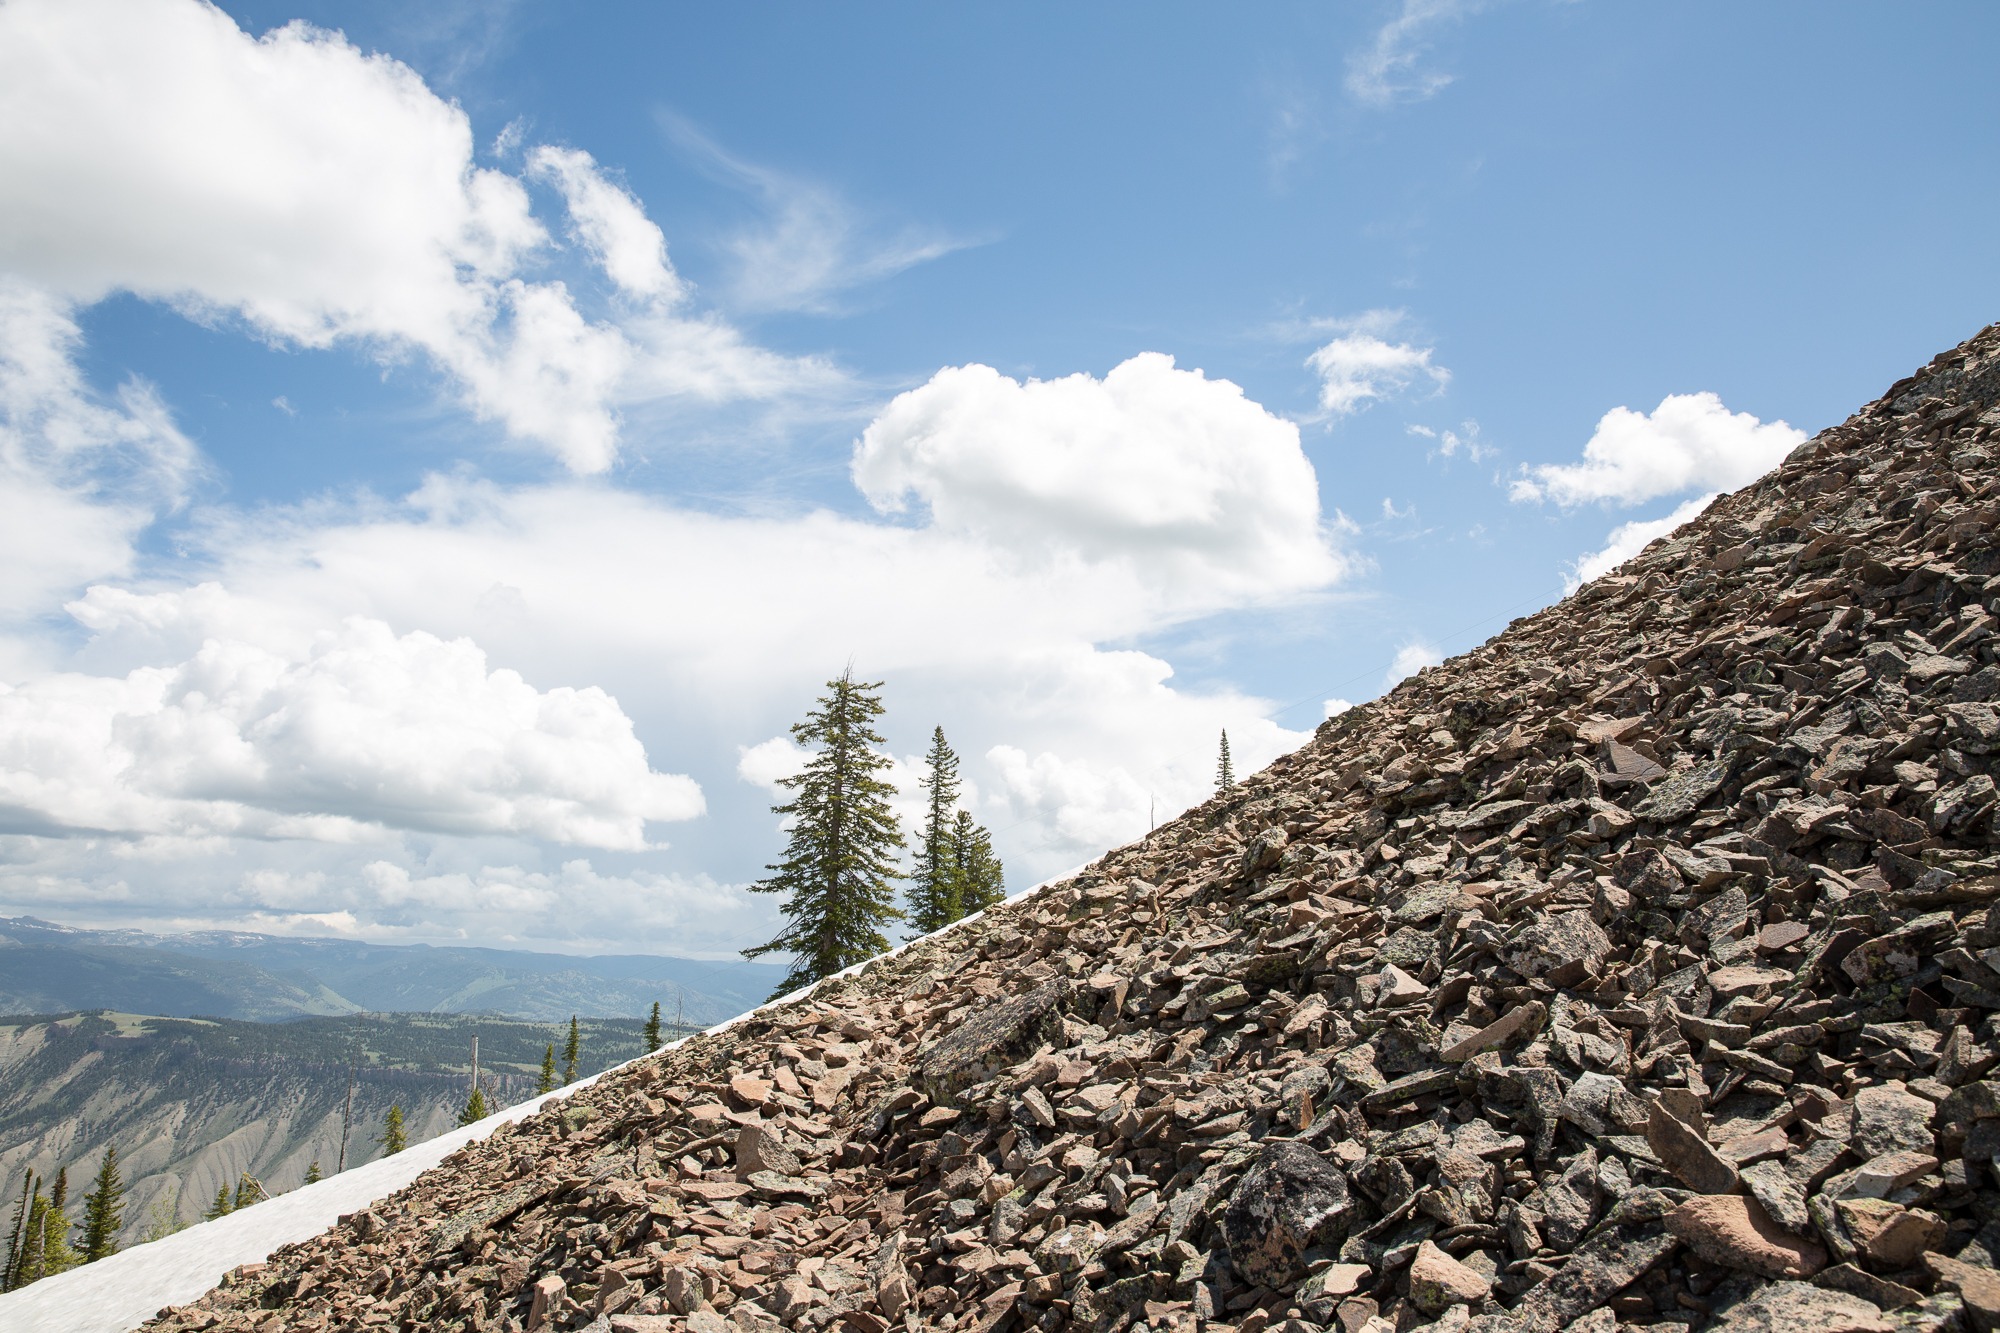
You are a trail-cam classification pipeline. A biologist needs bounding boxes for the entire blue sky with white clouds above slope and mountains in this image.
[0,0,2000,953]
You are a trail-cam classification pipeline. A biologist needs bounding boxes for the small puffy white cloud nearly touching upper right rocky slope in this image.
[1510,392,1806,506]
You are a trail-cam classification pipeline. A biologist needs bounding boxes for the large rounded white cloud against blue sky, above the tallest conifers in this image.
[854,352,1344,602]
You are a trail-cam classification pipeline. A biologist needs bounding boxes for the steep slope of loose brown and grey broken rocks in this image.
[152,326,2000,1333]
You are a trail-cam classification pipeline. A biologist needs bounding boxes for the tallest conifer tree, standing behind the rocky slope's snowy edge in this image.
[744,667,904,999]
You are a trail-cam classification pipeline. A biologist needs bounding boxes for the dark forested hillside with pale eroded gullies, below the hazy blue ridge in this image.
[0,1013,642,1243]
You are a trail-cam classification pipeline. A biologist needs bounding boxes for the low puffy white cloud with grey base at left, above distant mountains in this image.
[0,602,702,851]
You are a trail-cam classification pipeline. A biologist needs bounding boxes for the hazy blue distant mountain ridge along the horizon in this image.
[0,917,784,1025]
